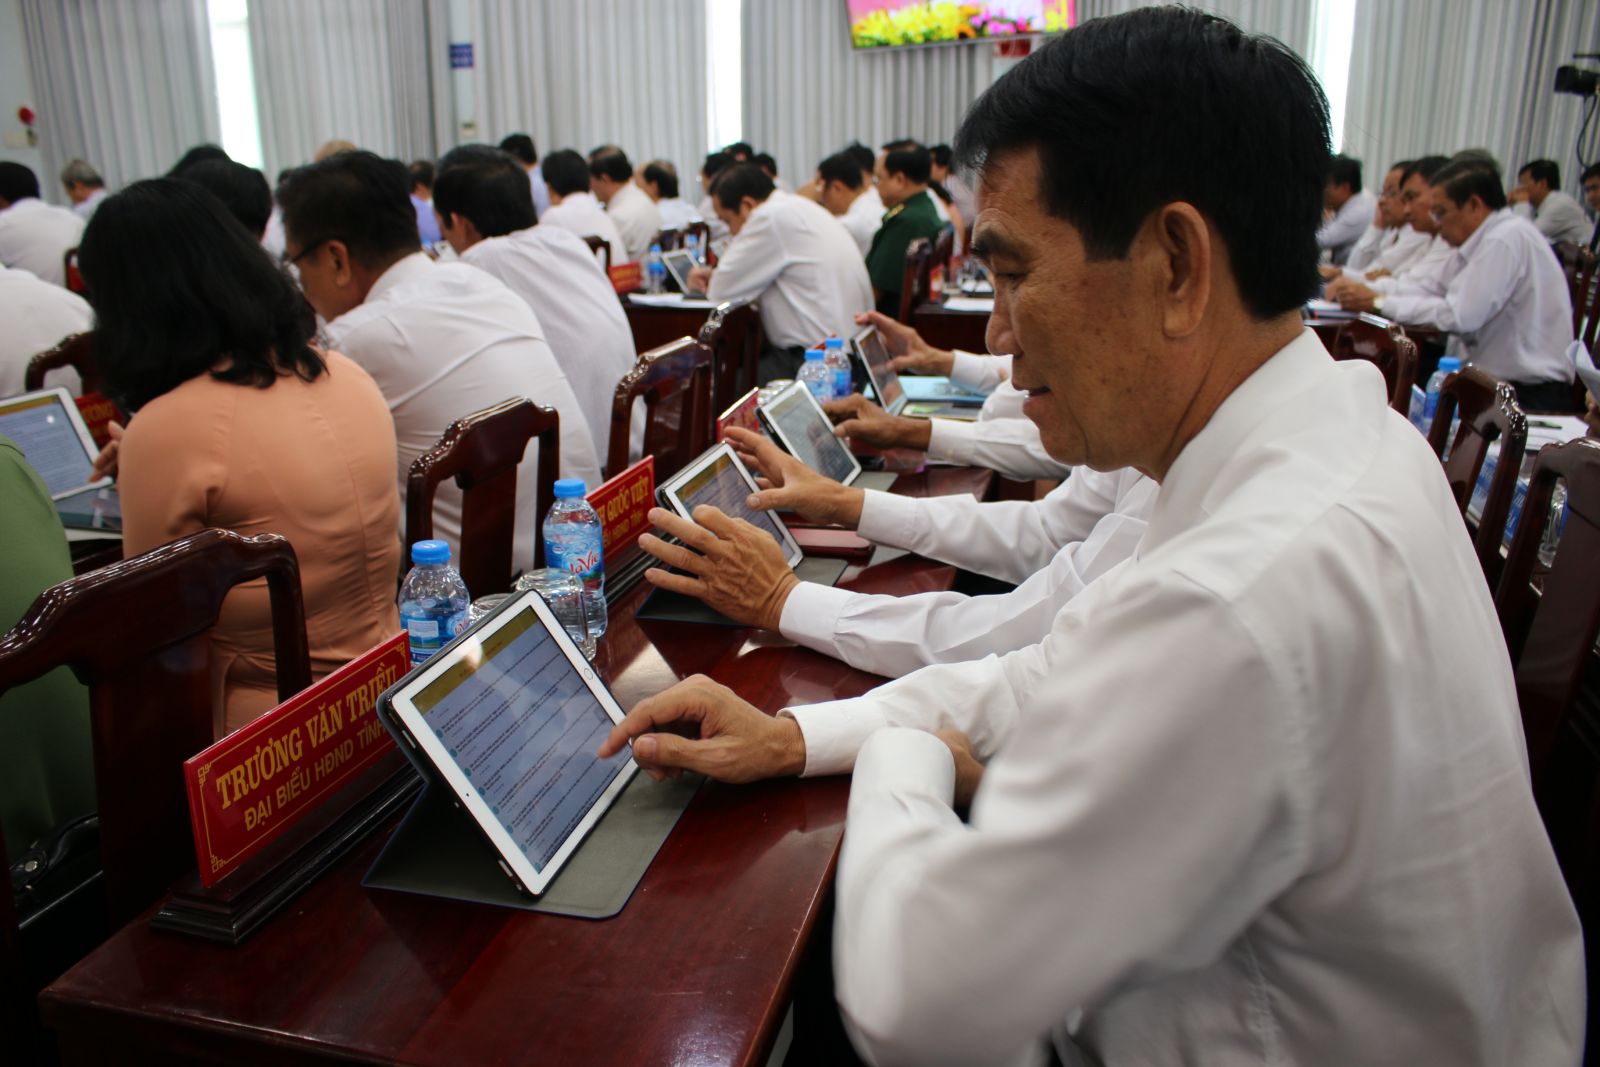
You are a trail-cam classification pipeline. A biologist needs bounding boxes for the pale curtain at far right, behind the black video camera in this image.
[1344,0,1600,194]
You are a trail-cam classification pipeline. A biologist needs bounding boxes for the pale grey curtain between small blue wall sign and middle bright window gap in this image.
[430,0,706,183]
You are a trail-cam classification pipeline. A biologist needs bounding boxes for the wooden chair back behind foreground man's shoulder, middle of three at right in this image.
[1427,366,1528,585]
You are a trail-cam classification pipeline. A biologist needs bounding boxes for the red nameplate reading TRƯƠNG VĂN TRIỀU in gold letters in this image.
[184,633,411,888]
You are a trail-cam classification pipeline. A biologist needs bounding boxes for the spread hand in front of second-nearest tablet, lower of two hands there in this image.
[638,504,800,630]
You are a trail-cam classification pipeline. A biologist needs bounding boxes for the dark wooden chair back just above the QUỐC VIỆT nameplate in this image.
[604,338,717,479]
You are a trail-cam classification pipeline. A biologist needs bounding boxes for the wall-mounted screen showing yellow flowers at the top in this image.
[846,0,1078,48]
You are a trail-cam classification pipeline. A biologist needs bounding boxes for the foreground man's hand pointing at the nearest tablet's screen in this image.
[598,675,805,782]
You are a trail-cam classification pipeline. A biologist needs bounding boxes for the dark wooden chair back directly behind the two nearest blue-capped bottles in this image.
[400,397,562,595]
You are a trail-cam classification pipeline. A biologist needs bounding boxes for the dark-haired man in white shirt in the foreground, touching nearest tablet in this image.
[602,8,1584,1067]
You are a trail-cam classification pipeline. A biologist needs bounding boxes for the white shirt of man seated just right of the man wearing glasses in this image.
[461,226,645,466]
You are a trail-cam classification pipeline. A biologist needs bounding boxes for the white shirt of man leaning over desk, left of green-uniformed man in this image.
[706,190,872,349]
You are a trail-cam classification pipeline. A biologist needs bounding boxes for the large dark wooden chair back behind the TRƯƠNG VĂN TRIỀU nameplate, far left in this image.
[0,530,310,1051]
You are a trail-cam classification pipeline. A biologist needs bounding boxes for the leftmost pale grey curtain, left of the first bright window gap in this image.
[21,0,221,203]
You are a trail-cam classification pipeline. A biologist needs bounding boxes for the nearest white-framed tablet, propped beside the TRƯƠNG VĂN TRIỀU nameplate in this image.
[382,590,638,896]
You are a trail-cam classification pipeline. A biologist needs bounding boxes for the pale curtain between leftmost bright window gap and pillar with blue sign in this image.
[250,0,438,181]
